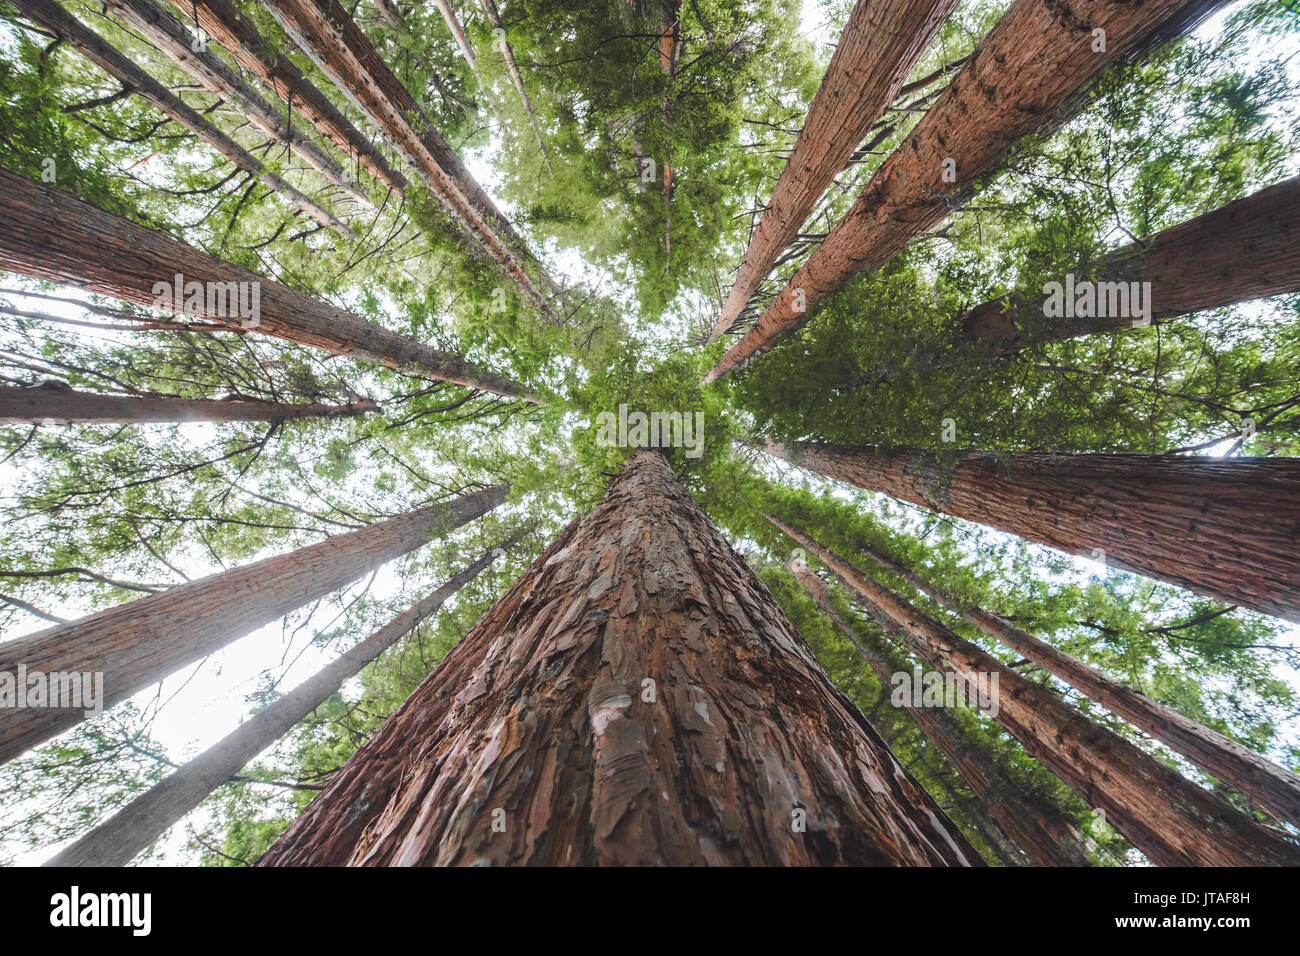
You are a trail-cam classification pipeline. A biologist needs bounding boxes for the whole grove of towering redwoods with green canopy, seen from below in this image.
[0,0,1300,865]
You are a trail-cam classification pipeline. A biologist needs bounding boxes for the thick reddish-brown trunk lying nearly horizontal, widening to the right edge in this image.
[767,442,1300,620]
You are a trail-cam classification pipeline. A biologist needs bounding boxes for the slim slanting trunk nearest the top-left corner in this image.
[13,0,360,241]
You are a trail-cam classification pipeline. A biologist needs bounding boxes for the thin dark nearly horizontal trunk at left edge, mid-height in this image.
[0,382,378,424]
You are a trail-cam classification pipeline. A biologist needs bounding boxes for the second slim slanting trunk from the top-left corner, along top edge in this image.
[105,0,373,208]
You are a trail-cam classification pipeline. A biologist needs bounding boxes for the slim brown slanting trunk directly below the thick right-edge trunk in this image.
[767,515,1300,823]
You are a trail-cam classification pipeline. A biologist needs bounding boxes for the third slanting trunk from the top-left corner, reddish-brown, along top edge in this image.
[172,0,407,191]
